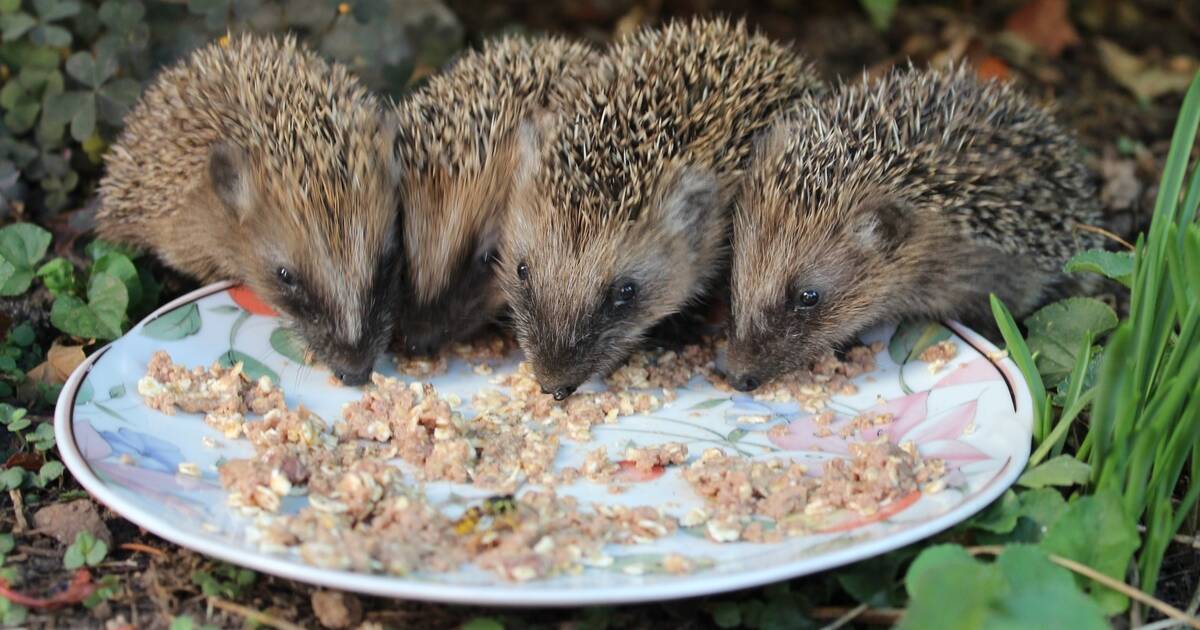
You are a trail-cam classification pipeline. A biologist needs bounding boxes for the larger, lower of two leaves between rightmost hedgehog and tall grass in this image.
[1025,298,1117,386]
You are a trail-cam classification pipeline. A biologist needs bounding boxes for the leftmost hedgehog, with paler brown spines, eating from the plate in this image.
[97,36,400,385]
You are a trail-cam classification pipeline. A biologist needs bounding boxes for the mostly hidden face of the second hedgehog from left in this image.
[395,160,511,354]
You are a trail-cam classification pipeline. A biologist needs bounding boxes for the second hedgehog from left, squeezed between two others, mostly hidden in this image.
[392,36,599,354]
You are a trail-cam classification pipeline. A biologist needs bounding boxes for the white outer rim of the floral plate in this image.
[54,281,1033,607]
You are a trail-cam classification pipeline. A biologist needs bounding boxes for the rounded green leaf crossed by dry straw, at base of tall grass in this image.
[1042,492,1139,614]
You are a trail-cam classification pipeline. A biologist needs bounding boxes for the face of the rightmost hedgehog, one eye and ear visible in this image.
[726,198,905,391]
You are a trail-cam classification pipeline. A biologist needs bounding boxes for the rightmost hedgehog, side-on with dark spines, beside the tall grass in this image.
[725,65,1102,391]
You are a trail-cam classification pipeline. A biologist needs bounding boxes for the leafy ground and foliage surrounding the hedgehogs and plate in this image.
[0,0,1200,630]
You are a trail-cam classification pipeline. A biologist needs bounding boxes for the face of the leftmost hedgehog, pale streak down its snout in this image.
[209,138,401,385]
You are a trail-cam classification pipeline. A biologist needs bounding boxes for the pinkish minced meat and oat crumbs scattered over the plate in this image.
[138,337,944,582]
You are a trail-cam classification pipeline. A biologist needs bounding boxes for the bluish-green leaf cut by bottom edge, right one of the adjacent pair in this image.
[995,545,1109,630]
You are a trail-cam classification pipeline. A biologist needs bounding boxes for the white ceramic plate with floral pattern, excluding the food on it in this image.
[55,284,1032,606]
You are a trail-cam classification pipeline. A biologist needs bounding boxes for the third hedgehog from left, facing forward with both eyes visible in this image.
[499,19,818,400]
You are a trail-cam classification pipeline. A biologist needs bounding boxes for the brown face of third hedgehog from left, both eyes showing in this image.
[499,119,727,400]
